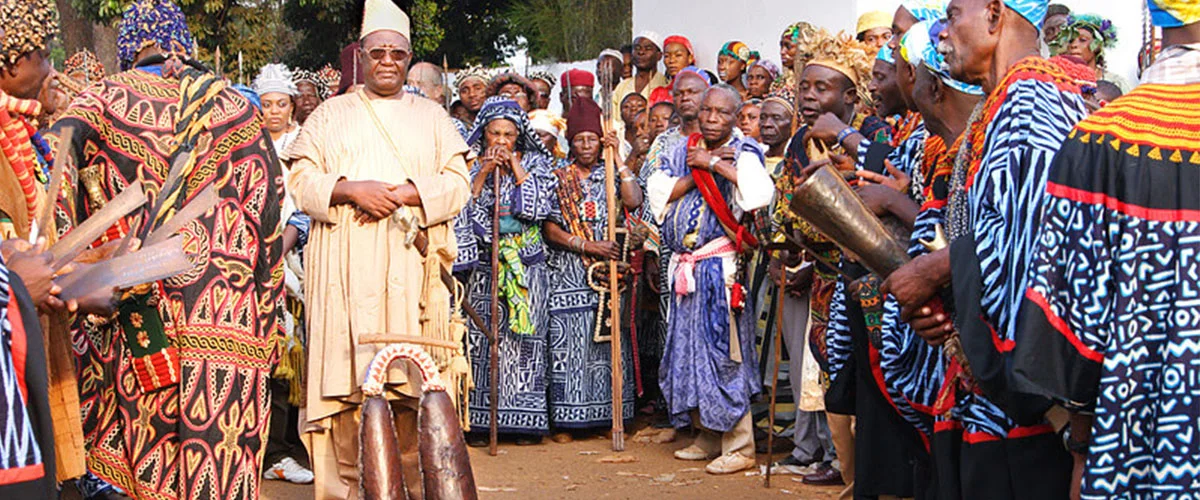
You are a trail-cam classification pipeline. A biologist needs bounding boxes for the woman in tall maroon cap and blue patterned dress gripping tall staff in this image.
[545,97,642,442]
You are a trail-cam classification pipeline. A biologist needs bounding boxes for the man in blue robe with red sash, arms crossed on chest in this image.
[647,85,774,474]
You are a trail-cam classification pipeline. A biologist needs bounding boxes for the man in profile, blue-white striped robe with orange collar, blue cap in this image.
[884,0,1086,499]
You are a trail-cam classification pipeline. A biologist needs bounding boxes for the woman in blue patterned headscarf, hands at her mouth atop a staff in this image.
[467,97,556,446]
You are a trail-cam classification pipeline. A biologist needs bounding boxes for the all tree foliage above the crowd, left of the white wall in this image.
[71,0,631,74]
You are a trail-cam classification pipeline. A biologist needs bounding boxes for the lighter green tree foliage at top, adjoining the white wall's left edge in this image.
[509,0,632,62]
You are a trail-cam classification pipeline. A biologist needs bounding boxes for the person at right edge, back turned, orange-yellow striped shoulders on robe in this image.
[1013,0,1200,499]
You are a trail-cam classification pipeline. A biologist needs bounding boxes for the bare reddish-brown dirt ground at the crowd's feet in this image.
[263,422,841,500]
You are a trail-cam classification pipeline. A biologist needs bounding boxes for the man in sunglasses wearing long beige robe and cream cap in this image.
[288,0,469,499]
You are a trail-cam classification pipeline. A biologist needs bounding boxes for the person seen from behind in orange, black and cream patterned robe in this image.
[54,0,283,499]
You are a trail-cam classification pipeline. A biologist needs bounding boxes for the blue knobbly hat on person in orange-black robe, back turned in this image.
[116,0,196,71]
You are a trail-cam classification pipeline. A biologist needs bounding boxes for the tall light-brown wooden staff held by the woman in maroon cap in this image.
[600,72,625,451]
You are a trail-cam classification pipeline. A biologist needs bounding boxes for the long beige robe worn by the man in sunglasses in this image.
[287,90,470,422]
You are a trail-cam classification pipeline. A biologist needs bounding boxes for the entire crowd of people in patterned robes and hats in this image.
[0,0,1200,499]
